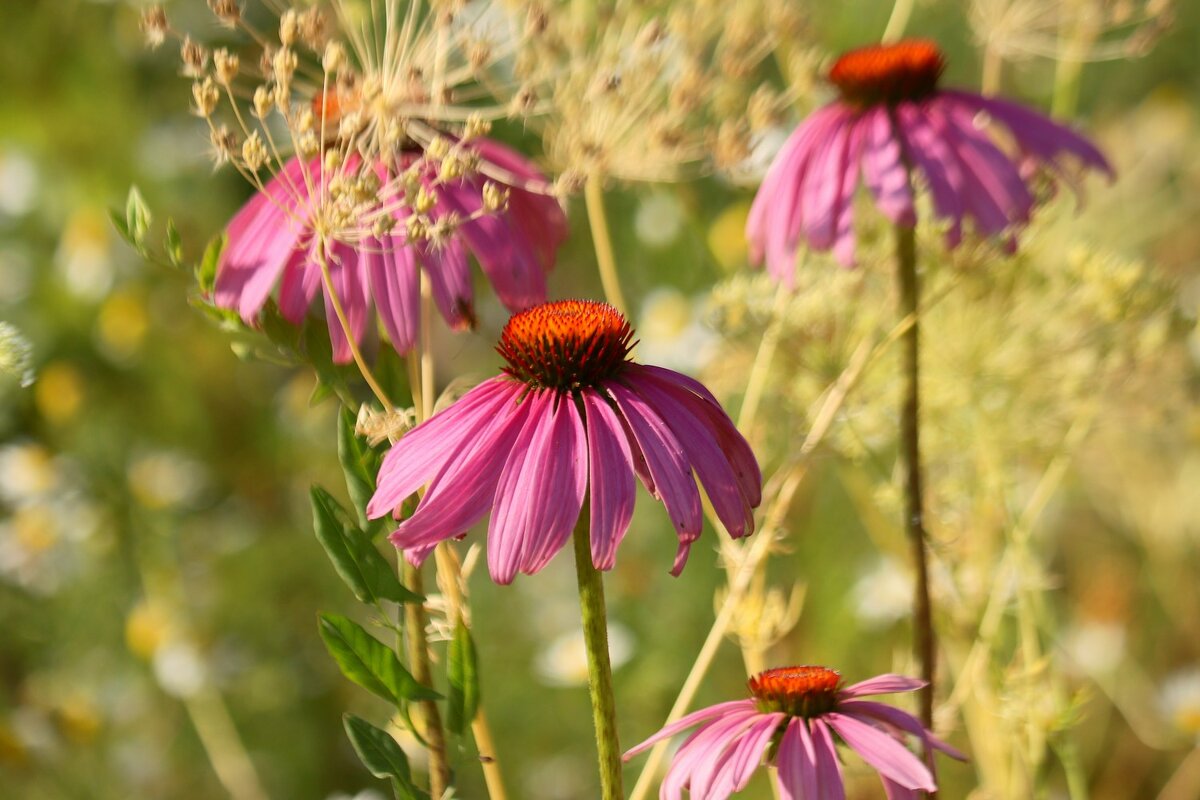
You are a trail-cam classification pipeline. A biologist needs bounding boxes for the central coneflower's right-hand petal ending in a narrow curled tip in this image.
[604,381,703,576]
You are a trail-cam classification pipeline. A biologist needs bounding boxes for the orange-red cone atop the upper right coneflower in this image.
[829,38,946,106]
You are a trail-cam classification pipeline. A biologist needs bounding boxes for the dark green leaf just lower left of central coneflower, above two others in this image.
[310,486,425,603]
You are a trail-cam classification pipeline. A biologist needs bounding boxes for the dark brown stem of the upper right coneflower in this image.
[896,224,934,728]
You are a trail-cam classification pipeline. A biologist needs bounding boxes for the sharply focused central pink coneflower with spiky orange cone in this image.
[367,300,762,583]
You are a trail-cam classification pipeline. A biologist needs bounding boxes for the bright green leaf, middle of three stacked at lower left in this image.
[319,614,442,705]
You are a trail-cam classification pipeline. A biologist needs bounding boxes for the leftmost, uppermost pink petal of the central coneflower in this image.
[367,378,523,519]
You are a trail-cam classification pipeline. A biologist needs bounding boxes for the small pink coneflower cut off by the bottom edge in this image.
[625,667,965,800]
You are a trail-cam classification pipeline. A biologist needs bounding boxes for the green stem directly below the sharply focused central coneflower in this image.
[574,513,625,800]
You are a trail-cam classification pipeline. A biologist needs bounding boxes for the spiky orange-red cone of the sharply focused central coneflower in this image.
[496,300,634,391]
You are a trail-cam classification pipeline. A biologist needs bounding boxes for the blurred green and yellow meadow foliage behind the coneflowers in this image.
[0,0,1200,800]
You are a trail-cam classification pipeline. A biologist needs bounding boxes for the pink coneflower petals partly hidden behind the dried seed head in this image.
[214,137,566,362]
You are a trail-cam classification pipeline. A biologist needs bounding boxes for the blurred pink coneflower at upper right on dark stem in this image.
[746,40,1112,278]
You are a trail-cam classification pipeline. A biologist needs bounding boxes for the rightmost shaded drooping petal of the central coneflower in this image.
[628,379,754,539]
